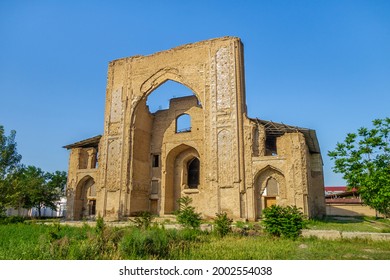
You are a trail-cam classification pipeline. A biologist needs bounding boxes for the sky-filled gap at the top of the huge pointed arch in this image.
[146,80,199,113]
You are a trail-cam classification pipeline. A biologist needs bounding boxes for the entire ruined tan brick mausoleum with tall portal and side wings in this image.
[65,37,325,220]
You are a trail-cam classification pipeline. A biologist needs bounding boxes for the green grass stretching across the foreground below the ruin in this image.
[0,219,390,260]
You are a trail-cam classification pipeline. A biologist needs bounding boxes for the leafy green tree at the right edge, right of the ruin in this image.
[328,118,390,217]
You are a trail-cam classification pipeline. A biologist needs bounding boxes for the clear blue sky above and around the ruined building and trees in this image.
[0,0,390,185]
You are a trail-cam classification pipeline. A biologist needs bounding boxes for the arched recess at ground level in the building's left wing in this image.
[73,175,96,220]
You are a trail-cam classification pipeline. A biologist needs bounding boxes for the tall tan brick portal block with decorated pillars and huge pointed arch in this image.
[98,37,246,219]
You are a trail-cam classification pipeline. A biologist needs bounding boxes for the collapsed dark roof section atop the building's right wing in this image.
[250,118,320,154]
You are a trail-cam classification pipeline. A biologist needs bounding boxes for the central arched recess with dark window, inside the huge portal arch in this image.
[164,144,202,214]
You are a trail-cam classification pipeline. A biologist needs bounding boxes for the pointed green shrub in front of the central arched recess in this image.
[175,196,202,229]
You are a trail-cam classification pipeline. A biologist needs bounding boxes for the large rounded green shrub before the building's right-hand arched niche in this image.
[262,205,306,239]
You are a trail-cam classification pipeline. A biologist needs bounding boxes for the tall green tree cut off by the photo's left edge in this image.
[0,125,22,215]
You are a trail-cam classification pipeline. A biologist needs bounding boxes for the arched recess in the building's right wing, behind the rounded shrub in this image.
[254,166,286,218]
